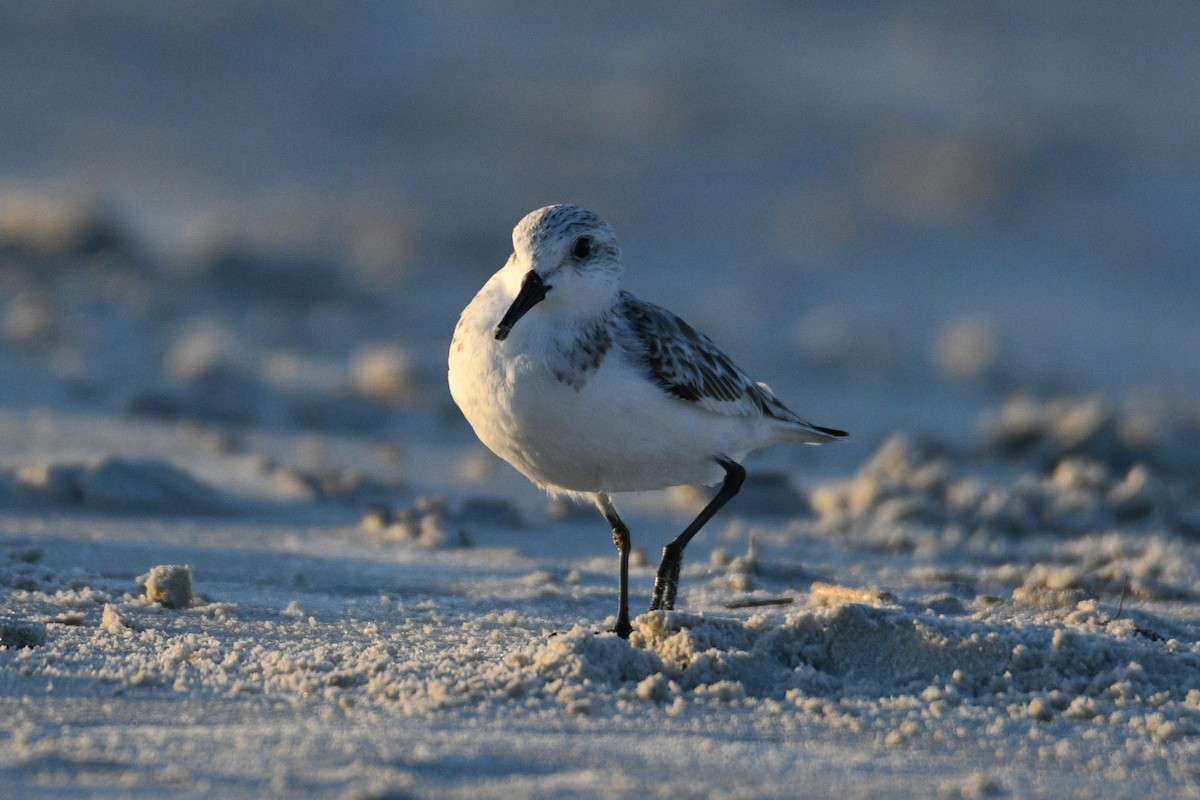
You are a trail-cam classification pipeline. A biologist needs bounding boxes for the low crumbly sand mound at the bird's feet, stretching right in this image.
[520,604,1200,704]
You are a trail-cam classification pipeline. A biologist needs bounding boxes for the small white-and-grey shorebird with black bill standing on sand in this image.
[449,205,846,638]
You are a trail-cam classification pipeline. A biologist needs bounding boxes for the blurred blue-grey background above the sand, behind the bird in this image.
[0,0,1200,470]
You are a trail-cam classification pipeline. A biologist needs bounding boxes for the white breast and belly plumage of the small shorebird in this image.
[449,277,760,493]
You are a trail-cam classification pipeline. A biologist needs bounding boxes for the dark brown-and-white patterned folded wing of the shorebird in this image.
[618,293,845,440]
